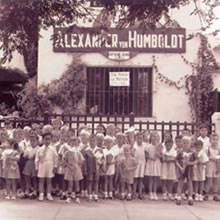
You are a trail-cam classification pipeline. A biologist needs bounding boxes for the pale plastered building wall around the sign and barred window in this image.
[38,2,220,122]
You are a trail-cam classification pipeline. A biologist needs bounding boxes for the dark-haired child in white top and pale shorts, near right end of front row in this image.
[193,140,209,202]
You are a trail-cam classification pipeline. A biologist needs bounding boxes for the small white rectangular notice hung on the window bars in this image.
[109,71,130,86]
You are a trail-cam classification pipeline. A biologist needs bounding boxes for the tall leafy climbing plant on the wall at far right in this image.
[186,34,219,123]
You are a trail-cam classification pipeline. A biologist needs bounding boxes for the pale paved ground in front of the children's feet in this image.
[0,198,220,220]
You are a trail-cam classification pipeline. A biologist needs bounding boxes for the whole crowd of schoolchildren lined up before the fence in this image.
[0,118,220,205]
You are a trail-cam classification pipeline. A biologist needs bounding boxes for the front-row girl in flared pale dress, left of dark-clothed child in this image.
[63,137,84,203]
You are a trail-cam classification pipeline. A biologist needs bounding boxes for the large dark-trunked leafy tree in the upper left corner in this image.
[0,0,90,76]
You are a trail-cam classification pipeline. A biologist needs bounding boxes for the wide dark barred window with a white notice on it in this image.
[86,67,152,117]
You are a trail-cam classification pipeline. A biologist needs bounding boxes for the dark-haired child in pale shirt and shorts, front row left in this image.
[35,133,58,201]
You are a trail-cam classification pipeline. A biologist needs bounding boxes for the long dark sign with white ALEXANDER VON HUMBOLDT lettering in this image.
[54,28,186,53]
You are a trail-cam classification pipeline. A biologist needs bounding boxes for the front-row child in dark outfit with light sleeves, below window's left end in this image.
[84,135,103,202]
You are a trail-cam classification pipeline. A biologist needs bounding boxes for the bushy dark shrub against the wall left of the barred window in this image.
[18,62,86,118]
